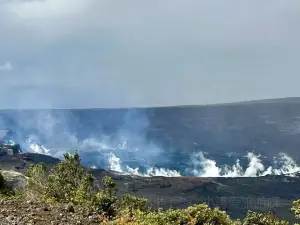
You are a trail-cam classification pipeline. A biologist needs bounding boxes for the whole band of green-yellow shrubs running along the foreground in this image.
[0,152,300,225]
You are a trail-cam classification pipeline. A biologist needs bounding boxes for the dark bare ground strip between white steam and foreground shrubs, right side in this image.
[93,170,300,220]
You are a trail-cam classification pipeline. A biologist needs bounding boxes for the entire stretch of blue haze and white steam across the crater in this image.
[0,110,300,177]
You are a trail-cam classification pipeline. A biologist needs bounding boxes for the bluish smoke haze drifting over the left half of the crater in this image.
[0,110,165,171]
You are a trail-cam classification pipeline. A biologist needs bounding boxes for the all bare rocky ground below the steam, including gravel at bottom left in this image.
[0,147,300,224]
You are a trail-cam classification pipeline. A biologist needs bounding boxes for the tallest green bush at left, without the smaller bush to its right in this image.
[26,152,96,207]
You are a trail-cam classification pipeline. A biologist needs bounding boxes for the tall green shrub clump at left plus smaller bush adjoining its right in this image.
[26,155,123,218]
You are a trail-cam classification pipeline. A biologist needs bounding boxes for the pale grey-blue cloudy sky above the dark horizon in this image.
[0,0,300,109]
